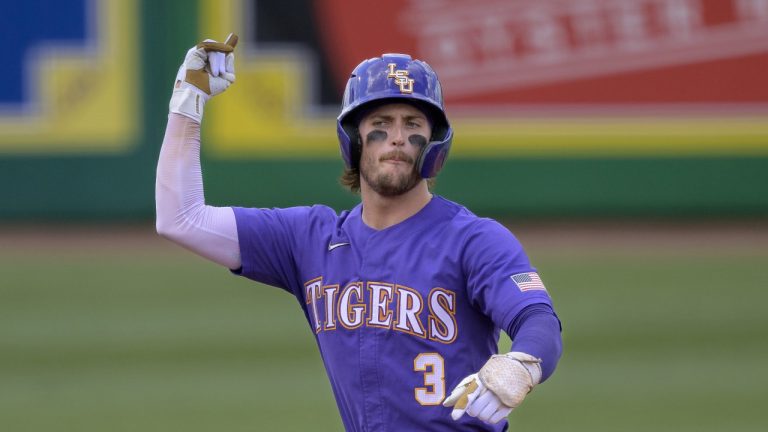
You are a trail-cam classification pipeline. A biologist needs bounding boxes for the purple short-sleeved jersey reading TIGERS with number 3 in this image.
[234,196,551,432]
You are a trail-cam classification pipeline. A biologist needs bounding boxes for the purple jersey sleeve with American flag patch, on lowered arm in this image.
[462,219,552,329]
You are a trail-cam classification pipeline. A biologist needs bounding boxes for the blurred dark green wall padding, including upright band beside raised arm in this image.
[0,0,768,221]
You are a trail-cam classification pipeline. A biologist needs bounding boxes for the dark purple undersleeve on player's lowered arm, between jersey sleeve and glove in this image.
[508,304,563,382]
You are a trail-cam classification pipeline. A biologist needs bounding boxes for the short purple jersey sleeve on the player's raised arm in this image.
[233,207,316,294]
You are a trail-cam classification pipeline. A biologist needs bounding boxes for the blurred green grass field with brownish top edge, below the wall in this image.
[0,227,768,432]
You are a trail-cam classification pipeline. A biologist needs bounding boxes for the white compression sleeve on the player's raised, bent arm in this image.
[155,113,241,269]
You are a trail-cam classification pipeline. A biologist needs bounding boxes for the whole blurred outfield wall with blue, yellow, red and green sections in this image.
[0,0,768,221]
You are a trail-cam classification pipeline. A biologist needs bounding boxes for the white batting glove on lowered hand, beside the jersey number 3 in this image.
[443,352,541,424]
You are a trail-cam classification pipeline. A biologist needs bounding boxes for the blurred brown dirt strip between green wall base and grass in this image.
[0,220,768,255]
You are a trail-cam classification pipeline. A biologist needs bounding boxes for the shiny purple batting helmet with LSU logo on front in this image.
[336,54,453,178]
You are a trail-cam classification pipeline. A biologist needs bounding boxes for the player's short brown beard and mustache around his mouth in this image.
[360,150,421,197]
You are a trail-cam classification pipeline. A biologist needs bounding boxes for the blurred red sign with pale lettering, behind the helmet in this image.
[318,0,768,107]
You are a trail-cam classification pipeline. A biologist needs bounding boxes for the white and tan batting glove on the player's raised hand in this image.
[169,33,237,123]
